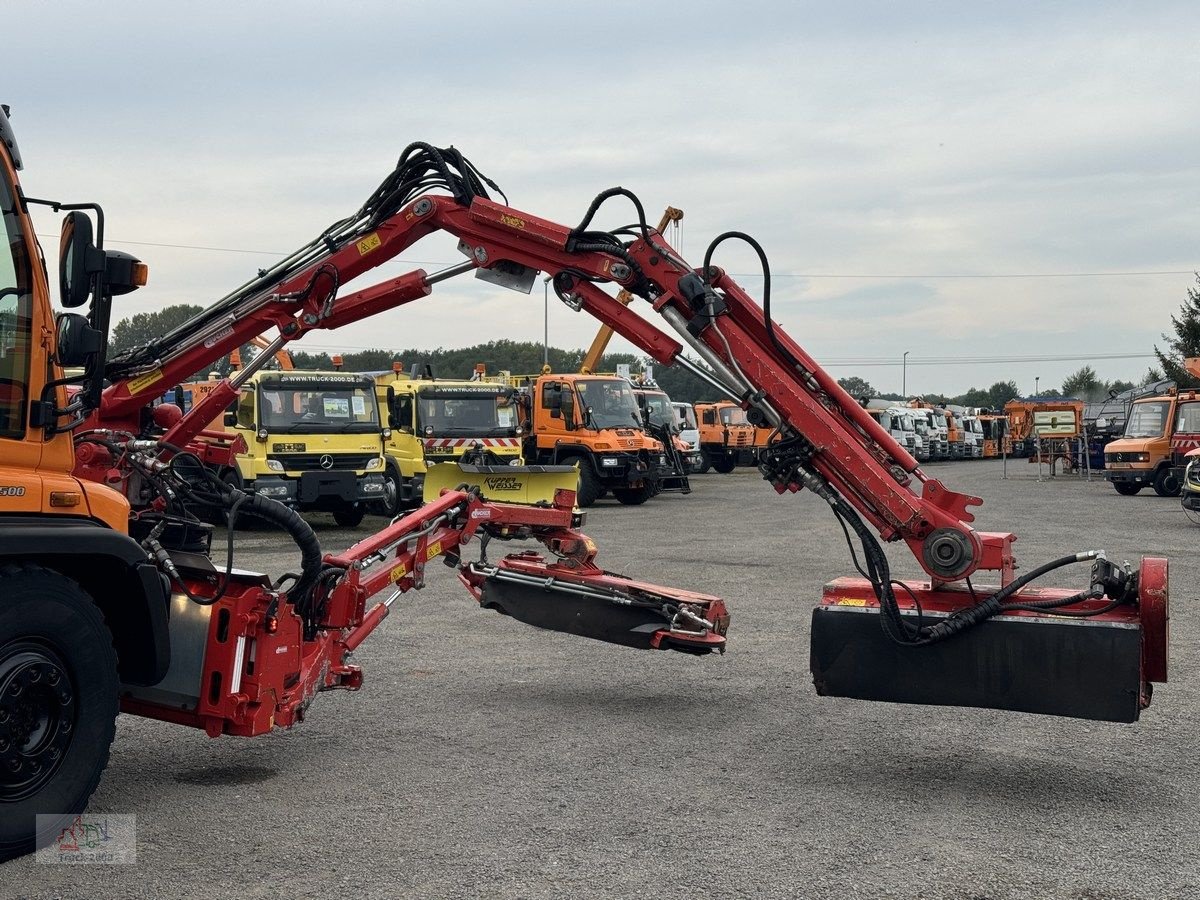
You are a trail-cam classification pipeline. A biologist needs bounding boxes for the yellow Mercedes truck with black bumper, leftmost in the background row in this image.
[222,371,388,528]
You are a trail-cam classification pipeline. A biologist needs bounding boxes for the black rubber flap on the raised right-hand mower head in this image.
[811,606,1141,722]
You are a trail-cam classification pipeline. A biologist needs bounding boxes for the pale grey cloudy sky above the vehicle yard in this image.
[0,0,1200,394]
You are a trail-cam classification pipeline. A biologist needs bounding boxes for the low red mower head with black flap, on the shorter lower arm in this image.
[467,554,730,654]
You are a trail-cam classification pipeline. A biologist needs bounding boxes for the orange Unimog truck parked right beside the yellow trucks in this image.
[509,372,674,506]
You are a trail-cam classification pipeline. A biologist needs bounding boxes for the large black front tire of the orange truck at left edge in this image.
[0,564,118,863]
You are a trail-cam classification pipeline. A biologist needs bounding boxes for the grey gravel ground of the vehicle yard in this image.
[0,461,1200,900]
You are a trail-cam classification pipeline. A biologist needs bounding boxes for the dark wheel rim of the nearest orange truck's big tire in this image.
[0,641,76,802]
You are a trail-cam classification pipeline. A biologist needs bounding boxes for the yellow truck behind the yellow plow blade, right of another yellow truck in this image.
[374,371,523,516]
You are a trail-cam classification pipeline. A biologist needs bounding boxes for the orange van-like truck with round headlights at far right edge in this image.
[1104,389,1198,497]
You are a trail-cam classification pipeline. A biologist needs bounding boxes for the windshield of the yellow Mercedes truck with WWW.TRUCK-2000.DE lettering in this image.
[258,376,380,434]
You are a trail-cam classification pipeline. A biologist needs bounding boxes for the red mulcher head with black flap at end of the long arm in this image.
[811,560,1166,722]
